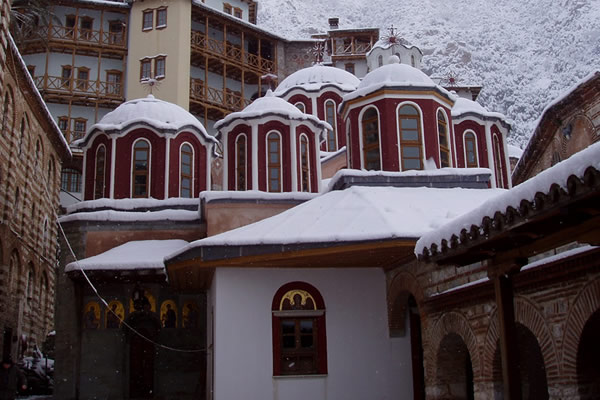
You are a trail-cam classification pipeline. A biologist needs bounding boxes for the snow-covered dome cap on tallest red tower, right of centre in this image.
[358,61,436,89]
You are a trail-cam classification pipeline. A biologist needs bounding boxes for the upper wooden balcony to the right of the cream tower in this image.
[191,31,276,74]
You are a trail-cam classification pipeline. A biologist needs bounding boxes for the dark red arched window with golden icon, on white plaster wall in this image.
[271,282,327,376]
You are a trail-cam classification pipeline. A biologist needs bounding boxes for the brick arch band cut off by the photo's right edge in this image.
[562,278,600,379]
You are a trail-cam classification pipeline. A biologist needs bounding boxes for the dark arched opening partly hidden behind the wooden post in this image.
[492,322,548,400]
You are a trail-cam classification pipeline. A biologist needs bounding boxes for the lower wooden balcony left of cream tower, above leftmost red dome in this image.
[34,75,125,106]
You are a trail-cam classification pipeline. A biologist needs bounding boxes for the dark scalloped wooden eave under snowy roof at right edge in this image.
[419,167,600,265]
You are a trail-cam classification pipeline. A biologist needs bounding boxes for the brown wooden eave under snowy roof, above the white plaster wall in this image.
[166,238,416,290]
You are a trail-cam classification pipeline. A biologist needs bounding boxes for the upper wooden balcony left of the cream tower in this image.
[23,25,127,54]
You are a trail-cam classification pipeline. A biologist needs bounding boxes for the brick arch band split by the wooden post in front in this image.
[482,296,559,383]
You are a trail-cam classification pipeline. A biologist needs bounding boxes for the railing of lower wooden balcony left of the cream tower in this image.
[34,75,123,99]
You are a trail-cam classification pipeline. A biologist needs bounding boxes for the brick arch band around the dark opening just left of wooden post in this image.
[425,311,482,379]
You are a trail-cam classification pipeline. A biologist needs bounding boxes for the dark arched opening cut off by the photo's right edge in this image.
[577,310,600,400]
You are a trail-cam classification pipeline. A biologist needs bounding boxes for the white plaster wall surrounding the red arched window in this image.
[211,268,412,400]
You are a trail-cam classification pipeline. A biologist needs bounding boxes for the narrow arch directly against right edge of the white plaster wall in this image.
[387,272,425,336]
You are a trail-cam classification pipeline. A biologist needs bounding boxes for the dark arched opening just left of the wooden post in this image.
[436,333,475,400]
